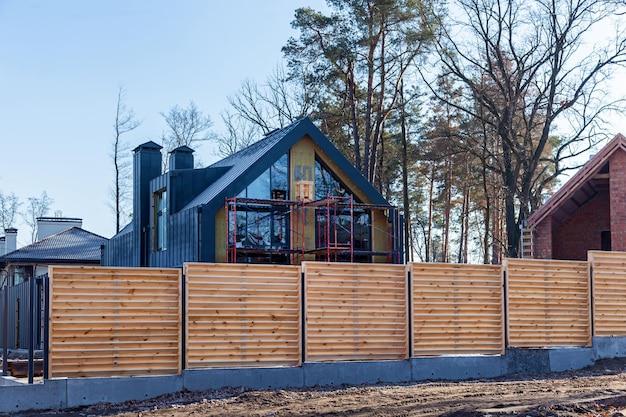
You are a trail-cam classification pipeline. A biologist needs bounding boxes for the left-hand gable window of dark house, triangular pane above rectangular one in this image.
[229,154,289,263]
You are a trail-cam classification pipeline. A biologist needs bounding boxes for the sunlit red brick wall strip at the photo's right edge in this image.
[609,149,626,251]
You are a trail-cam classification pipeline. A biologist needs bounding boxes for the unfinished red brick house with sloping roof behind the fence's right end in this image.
[521,134,626,260]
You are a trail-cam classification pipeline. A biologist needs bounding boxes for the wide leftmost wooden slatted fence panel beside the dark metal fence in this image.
[49,266,182,378]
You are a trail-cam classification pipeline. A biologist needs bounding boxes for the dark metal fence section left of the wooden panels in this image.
[0,274,49,384]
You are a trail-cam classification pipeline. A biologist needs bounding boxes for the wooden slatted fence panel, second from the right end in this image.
[503,259,591,348]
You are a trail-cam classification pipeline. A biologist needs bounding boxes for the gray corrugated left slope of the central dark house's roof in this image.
[184,118,305,209]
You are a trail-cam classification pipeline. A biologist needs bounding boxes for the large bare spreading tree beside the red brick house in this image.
[422,0,626,256]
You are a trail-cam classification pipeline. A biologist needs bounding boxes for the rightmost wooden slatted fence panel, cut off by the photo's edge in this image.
[588,251,626,336]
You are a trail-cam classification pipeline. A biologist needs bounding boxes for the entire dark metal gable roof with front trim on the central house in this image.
[183,117,388,209]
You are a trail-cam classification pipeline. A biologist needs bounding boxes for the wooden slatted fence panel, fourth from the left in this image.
[410,263,504,356]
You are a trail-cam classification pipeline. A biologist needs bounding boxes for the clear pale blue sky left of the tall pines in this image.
[0,0,324,244]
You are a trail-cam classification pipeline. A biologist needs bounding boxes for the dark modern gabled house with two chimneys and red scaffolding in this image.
[102,118,403,266]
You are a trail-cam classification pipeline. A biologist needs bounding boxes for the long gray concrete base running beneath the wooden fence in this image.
[0,337,626,413]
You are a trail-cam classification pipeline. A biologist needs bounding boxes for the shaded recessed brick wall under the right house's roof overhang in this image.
[552,191,611,261]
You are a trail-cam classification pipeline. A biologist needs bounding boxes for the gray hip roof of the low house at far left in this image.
[0,227,107,262]
